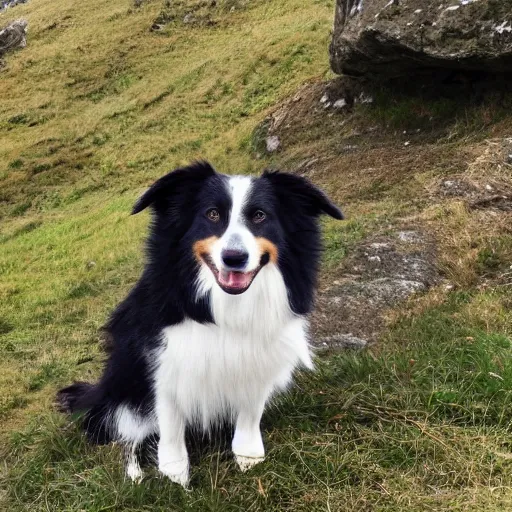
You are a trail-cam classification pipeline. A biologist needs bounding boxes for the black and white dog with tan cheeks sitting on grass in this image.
[58,162,343,486]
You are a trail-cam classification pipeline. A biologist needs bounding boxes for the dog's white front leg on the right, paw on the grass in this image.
[232,402,265,471]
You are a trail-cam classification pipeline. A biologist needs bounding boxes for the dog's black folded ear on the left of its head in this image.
[132,162,216,215]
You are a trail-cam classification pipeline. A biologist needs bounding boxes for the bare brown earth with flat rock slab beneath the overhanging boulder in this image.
[262,79,512,349]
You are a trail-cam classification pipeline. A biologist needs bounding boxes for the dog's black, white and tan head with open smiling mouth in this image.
[133,162,343,308]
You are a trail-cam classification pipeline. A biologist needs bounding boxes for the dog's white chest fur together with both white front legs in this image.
[155,263,312,485]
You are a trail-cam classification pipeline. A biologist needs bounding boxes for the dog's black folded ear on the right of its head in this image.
[263,171,343,220]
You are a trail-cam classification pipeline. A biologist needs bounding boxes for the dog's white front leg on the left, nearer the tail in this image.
[156,393,189,487]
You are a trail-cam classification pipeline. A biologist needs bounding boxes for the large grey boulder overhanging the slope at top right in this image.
[330,0,512,78]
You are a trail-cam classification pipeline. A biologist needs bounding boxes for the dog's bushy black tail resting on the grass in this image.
[56,382,112,444]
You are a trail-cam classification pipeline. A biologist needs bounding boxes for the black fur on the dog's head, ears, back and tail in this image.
[58,162,342,442]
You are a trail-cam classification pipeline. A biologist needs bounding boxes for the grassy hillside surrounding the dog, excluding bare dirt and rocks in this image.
[0,0,512,511]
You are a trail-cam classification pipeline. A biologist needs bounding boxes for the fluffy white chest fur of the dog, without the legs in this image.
[155,265,312,428]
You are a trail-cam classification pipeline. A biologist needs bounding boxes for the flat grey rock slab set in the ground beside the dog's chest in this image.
[312,229,440,349]
